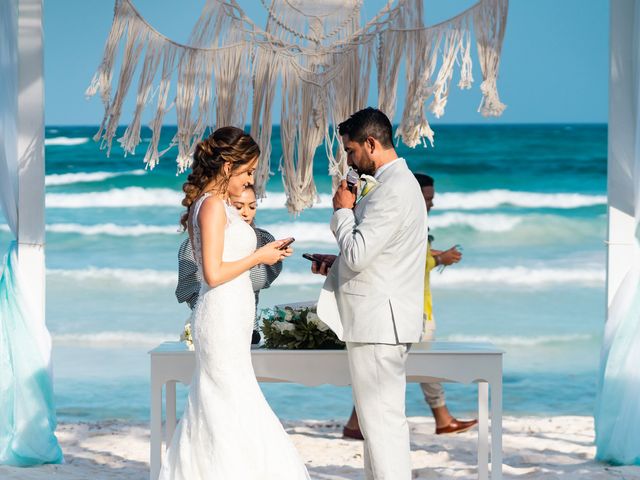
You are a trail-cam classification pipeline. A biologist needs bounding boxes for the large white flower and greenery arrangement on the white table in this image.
[261,303,345,350]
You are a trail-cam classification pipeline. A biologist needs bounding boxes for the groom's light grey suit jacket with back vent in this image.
[318,159,427,344]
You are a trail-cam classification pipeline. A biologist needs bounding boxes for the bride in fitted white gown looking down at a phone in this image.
[160,127,309,480]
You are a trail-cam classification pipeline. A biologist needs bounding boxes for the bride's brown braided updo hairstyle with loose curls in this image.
[180,127,260,230]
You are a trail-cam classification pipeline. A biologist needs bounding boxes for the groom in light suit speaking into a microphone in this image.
[312,108,427,480]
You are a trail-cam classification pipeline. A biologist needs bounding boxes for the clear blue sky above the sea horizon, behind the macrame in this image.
[44,0,609,125]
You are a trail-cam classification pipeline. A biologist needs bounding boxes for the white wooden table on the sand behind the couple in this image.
[149,342,504,480]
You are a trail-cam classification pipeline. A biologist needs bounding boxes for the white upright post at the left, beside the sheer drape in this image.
[18,0,51,362]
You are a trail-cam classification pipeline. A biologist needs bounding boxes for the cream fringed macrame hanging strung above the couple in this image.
[86,0,508,213]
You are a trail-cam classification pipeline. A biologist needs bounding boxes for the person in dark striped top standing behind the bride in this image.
[176,185,282,344]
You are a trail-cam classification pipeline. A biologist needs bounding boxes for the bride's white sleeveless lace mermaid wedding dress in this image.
[160,195,309,480]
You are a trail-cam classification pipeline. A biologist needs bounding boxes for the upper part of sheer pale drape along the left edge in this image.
[0,0,18,237]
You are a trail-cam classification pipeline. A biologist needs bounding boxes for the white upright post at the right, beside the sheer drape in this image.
[607,0,640,306]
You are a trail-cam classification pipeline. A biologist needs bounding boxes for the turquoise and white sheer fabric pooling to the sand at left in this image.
[0,241,63,467]
